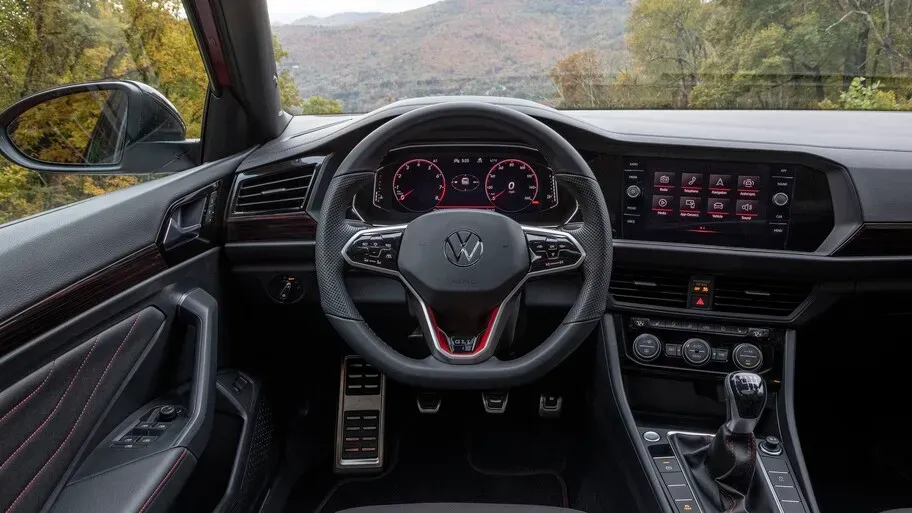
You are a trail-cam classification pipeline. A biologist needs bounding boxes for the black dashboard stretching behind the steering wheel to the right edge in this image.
[225,98,912,323]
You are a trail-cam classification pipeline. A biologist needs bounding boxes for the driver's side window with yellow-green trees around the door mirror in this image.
[0,0,208,225]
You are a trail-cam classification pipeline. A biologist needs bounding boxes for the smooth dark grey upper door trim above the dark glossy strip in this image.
[0,148,249,324]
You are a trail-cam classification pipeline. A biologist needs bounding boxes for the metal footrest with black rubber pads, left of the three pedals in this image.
[335,356,386,474]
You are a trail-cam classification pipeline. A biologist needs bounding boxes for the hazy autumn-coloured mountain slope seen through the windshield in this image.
[273,0,629,112]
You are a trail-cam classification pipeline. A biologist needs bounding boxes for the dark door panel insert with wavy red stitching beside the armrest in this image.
[0,307,165,511]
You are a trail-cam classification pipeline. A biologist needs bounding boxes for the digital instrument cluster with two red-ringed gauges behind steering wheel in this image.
[373,146,560,214]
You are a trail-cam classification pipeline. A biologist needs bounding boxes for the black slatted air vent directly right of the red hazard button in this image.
[713,276,811,316]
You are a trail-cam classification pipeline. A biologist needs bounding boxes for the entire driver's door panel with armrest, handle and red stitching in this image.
[0,147,245,513]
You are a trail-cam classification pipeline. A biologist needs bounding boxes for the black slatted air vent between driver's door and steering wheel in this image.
[232,157,322,215]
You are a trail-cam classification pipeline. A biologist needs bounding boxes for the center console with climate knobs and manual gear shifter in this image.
[602,312,819,513]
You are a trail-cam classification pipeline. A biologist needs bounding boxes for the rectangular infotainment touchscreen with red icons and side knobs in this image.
[622,157,795,249]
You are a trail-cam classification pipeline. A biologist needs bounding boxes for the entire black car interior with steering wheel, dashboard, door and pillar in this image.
[0,1,912,513]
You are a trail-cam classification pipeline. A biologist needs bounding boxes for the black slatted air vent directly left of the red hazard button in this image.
[609,267,690,308]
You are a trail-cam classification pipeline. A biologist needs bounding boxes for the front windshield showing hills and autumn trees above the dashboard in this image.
[268,0,912,114]
